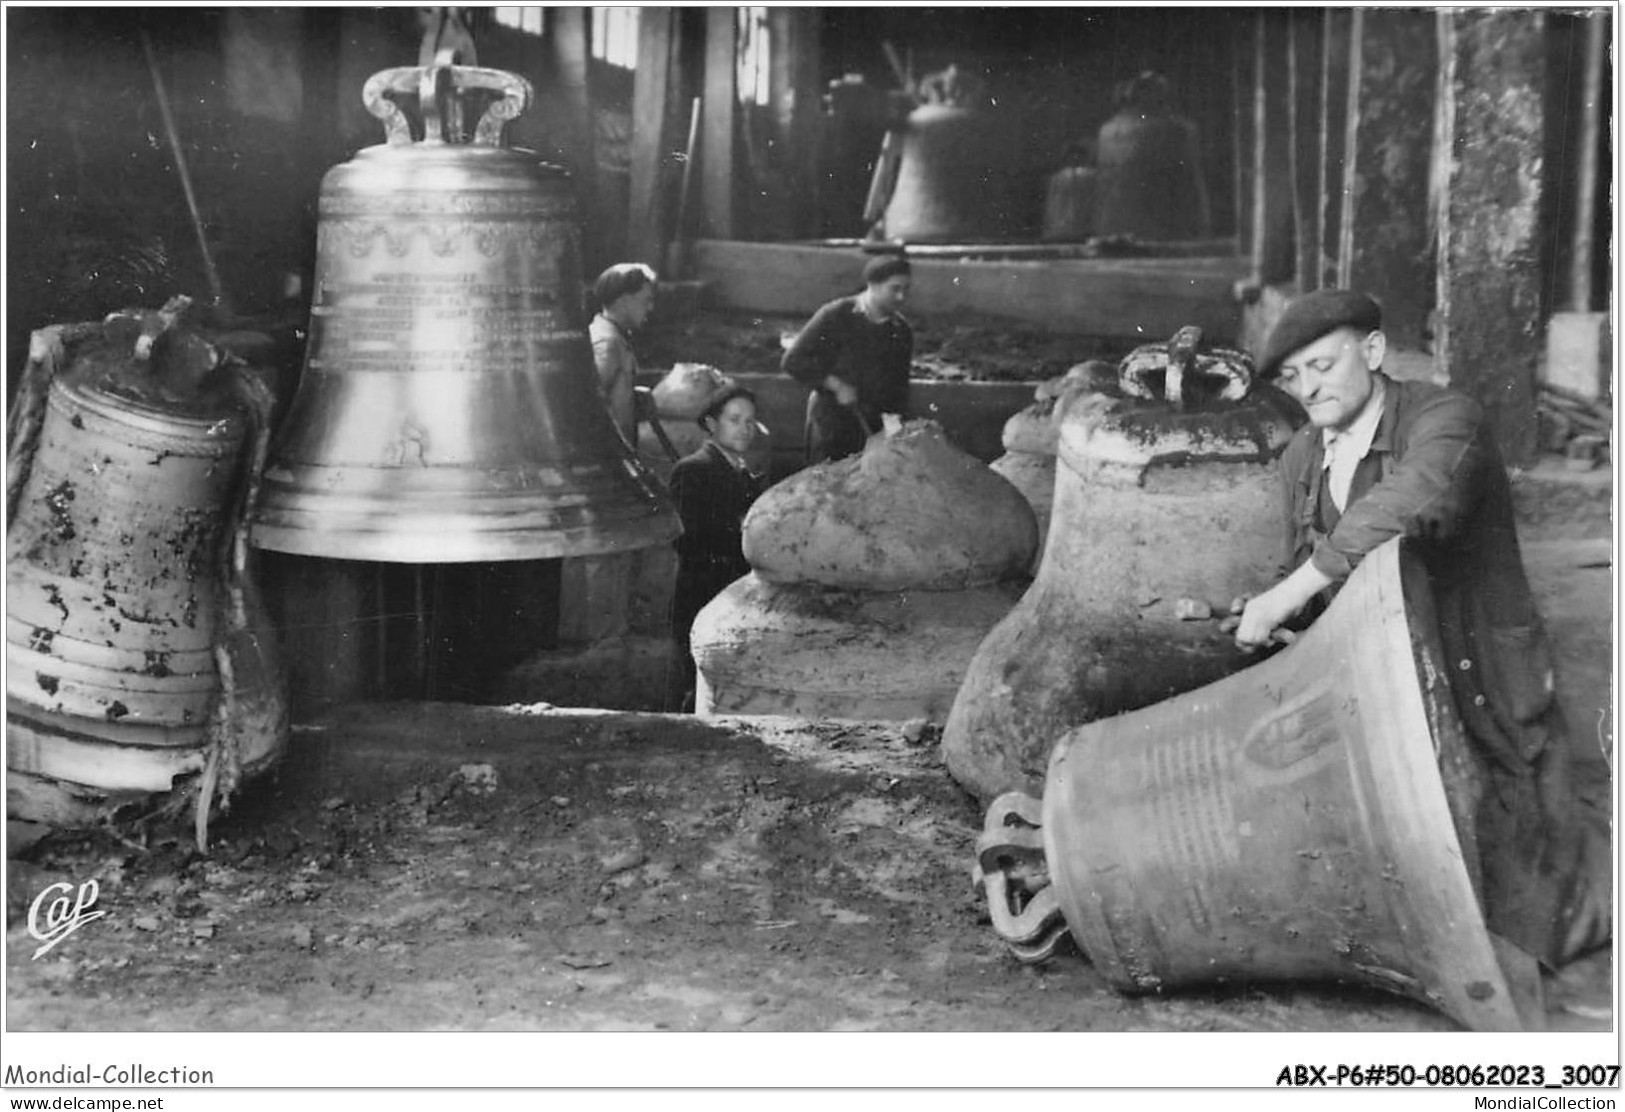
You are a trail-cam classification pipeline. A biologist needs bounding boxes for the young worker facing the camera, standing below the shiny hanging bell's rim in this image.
[666,385,764,710]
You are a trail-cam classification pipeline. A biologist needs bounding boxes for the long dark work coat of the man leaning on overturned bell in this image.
[1281,376,1584,964]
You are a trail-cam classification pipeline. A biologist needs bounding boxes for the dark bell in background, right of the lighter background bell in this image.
[1094,70,1209,239]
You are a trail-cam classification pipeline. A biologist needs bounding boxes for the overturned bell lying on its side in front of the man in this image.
[1020,540,1542,1031]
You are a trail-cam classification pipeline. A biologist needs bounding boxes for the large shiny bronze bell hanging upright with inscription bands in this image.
[254,65,679,564]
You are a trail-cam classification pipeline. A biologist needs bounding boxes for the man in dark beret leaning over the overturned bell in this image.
[1237,289,1614,967]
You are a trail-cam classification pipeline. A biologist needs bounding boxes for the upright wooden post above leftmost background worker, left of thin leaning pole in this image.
[626,8,676,267]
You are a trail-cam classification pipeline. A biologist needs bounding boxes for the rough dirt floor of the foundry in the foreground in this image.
[7,529,1612,1032]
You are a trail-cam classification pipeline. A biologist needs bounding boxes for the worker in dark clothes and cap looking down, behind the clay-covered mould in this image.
[783,255,913,463]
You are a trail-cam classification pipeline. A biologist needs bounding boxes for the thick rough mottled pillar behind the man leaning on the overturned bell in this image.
[1428,8,1545,463]
